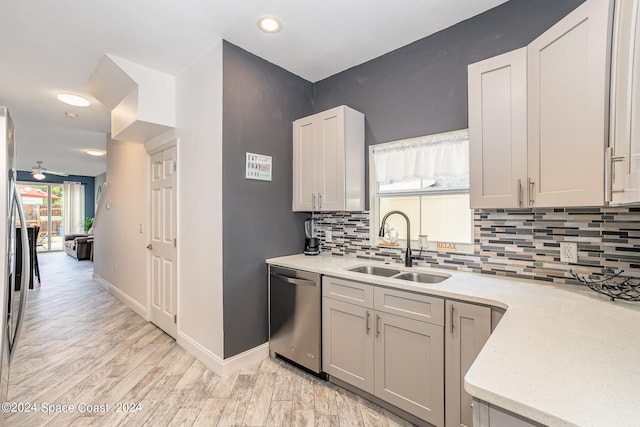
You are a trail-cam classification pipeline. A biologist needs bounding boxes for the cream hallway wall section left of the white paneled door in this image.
[93,138,148,318]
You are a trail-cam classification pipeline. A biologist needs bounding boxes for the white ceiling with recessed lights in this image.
[0,0,506,176]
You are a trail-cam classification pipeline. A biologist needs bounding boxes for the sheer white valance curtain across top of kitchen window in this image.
[373,129,469,183]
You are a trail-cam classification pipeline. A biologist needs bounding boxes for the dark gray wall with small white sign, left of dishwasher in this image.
[222,42,313,358]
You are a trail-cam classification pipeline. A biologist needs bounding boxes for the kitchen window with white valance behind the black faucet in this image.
[369,129,473,252]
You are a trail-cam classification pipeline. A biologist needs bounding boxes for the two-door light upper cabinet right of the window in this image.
[468,0,613,208]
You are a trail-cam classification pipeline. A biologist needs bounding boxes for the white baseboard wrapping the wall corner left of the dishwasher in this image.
[177,331,269,377]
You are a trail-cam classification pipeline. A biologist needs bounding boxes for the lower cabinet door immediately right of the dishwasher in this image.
[322,298,374,394]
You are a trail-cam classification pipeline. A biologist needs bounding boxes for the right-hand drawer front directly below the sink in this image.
[374,288,444,326]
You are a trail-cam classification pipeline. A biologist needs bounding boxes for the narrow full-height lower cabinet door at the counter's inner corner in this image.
[445,300,491,427]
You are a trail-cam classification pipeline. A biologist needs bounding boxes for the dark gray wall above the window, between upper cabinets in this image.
[314,0,584,208]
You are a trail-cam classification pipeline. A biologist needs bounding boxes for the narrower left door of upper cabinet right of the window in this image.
[468,47,527,208]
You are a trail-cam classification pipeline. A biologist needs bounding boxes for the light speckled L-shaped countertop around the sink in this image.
[267,255,640,427]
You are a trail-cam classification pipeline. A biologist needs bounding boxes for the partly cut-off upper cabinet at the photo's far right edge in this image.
[606,0,640,204]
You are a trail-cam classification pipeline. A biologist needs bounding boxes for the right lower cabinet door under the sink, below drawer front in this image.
[375,312,444,426]
